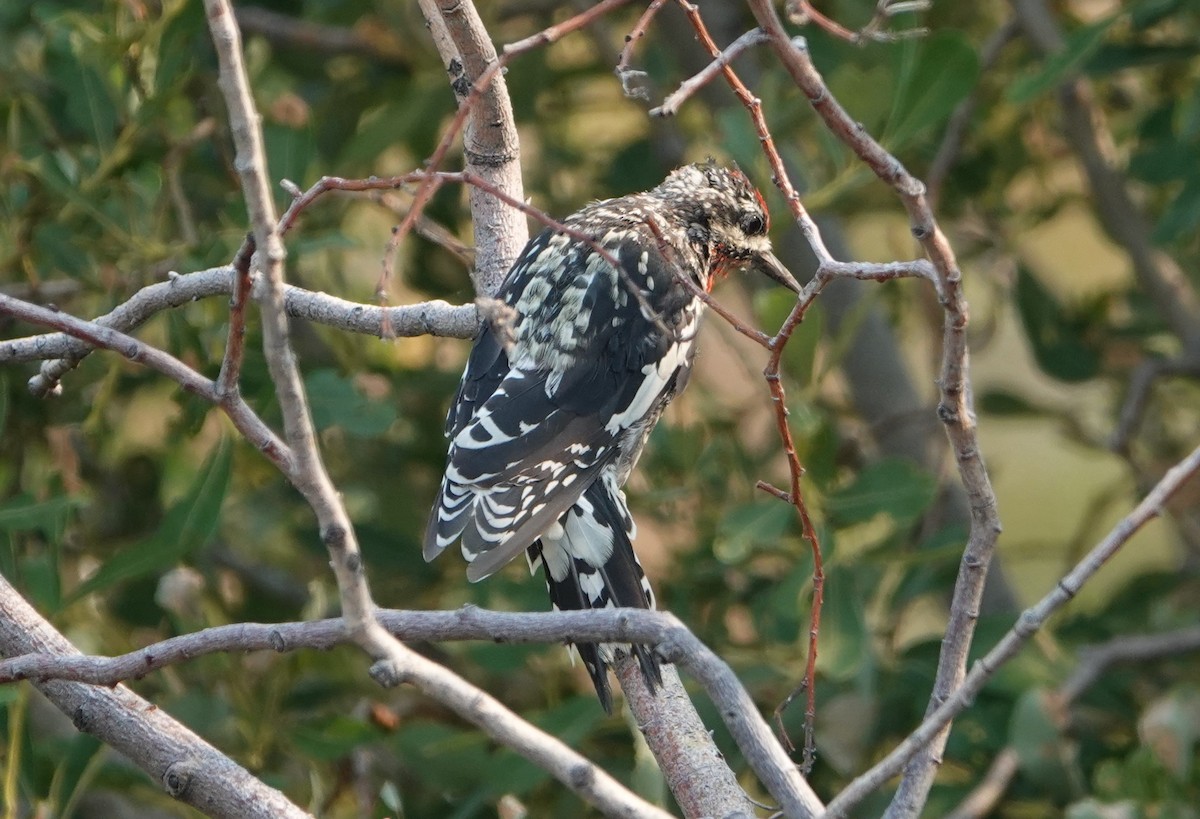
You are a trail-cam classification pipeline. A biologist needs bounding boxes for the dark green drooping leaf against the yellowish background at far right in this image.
[1016,265,1100,382]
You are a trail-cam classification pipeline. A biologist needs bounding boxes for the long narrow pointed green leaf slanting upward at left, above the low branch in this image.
[68,441,233,602]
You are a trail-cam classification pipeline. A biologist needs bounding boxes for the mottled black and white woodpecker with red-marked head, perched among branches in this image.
[424,160,802,713]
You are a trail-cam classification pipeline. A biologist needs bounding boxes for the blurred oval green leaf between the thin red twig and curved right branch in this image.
[826,458,937,526]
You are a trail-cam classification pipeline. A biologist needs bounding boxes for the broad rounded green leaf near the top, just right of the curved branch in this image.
[884,31,979,150]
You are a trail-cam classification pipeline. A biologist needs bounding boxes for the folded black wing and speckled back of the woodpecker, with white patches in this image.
[425,231,694,580]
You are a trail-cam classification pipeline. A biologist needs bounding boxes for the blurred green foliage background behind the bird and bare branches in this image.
[0,0,1200,818]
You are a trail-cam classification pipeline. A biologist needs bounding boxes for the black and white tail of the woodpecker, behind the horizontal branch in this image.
[526,479,662,713]
